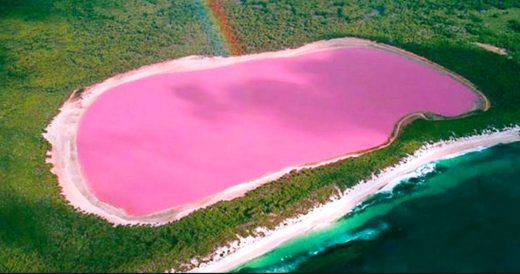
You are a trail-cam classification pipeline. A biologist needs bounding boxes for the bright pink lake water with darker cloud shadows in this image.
[77,48,477,216]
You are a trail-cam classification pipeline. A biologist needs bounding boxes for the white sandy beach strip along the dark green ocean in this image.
[191,126,520,272]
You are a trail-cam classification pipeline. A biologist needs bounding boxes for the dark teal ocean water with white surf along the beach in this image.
[235,142,520,272]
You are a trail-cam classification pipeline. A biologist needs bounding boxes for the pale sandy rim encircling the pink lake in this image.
[43,35,489,225]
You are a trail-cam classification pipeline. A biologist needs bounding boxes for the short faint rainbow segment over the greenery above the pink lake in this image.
[194,0,242,56]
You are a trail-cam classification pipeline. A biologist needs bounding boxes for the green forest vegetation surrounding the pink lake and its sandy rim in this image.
[0,0,520,272]
